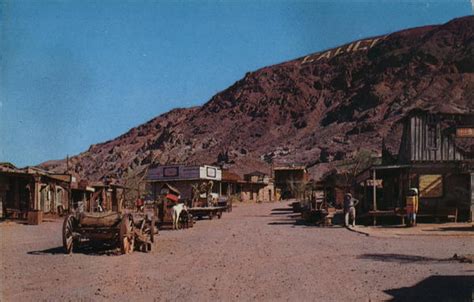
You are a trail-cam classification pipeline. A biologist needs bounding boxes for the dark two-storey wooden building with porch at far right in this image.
[359,110,474,221]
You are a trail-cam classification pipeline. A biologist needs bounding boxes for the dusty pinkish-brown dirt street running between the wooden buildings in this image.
[0,203,474,301]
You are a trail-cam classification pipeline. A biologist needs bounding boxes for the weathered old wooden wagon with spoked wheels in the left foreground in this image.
[63,212,155,254]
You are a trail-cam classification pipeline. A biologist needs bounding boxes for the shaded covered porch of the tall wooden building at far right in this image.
[357,163,474,224]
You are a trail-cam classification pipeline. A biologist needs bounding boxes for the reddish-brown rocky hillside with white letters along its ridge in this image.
[41,16,474,179]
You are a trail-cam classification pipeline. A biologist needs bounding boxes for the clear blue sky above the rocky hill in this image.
[0,0,472,166]
